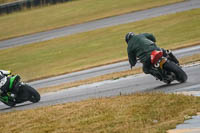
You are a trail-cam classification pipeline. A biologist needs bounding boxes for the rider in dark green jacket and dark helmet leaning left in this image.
[125,32,179,81]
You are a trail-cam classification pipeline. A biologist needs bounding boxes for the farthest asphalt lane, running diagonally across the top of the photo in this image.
[0,0,200,49]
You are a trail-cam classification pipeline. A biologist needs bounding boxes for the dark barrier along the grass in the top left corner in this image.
[0,0,72,14]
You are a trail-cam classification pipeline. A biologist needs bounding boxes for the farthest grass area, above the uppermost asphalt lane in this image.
[0,0,183,40]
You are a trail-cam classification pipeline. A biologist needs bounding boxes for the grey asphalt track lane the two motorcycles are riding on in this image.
[0,64,200,112]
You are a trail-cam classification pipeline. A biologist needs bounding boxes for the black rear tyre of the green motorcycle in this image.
[25,84,40,103]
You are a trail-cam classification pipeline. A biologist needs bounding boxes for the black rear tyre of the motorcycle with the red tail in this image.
[163,60,188,83]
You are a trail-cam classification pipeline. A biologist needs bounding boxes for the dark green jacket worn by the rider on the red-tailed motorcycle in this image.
[127,33,159,68]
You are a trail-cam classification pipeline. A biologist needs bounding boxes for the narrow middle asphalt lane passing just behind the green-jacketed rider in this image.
[29,45,200,88]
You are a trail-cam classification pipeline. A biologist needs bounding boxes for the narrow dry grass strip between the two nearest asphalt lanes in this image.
[38,54,200,94]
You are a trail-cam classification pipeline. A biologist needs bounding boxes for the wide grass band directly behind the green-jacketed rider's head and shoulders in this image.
[0,9,200,80]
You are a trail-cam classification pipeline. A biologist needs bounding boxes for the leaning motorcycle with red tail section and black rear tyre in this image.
[151,50,187,84]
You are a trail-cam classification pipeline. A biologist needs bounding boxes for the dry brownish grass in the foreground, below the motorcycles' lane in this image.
[0,93,200,133]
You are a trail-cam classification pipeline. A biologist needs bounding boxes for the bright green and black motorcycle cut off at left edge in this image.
[0,75,40,107]
